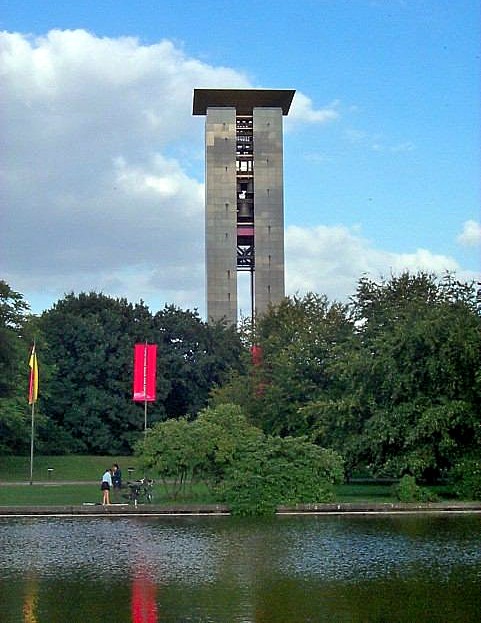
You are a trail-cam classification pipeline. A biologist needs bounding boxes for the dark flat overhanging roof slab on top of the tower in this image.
[192,89,296,115]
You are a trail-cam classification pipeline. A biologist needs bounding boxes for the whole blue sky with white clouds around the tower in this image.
[0,0,481,313]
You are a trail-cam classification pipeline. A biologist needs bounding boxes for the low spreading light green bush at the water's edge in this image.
[137,404,342,515]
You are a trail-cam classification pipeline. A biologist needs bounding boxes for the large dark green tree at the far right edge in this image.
[338,273,481,479]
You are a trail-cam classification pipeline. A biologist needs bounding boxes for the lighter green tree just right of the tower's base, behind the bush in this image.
[242,293,352,436]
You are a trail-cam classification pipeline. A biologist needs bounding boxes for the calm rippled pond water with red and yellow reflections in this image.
[0,515,481,623]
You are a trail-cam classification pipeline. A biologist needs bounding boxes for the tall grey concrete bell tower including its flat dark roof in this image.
[193,89,295,324]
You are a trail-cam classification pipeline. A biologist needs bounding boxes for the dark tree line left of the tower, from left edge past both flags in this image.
[0,284,242,454]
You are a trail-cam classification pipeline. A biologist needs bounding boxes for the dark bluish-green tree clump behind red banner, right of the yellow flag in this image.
[40,292,242,454]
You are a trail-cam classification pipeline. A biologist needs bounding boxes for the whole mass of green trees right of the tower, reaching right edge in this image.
[212,273,481,480]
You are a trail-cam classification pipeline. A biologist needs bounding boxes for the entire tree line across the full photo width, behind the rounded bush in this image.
[0,273,481,492]
